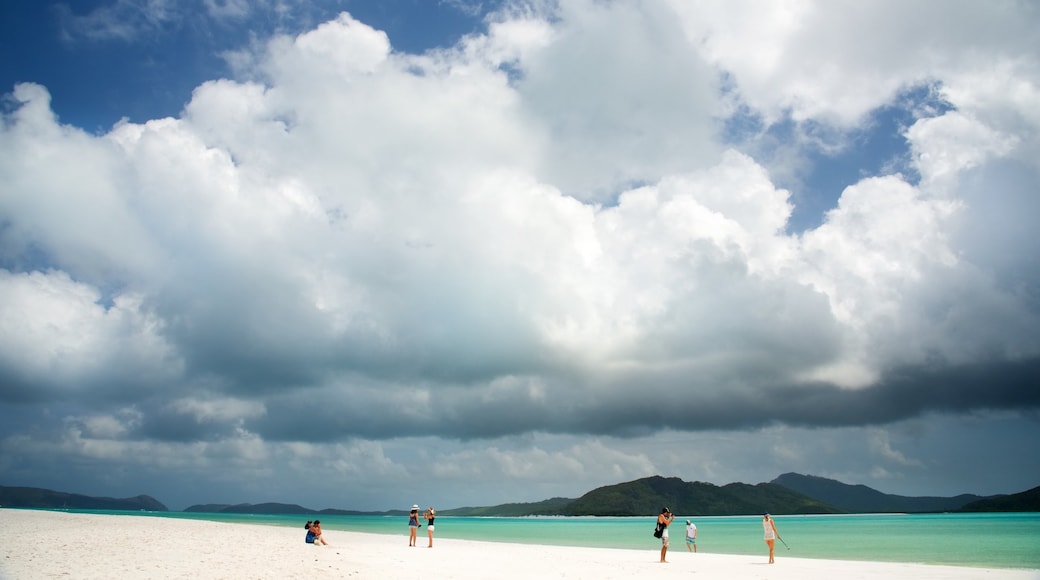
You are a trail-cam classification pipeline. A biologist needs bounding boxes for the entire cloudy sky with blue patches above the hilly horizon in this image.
[0,0,1040,510]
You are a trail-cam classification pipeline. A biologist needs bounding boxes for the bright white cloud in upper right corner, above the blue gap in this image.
[669,0,1037,126]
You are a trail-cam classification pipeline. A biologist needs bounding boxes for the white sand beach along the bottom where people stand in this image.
[0,509,1040,580]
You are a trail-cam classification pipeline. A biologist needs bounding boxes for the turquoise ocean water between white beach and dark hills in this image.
[36,510,1040,569]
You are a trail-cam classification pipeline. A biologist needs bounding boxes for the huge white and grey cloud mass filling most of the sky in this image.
[0,0,1040,509]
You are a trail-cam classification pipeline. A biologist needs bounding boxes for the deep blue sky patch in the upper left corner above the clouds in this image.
[0,0,499,133]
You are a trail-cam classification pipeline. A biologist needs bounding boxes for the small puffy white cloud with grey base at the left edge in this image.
[0,270,181,403]
